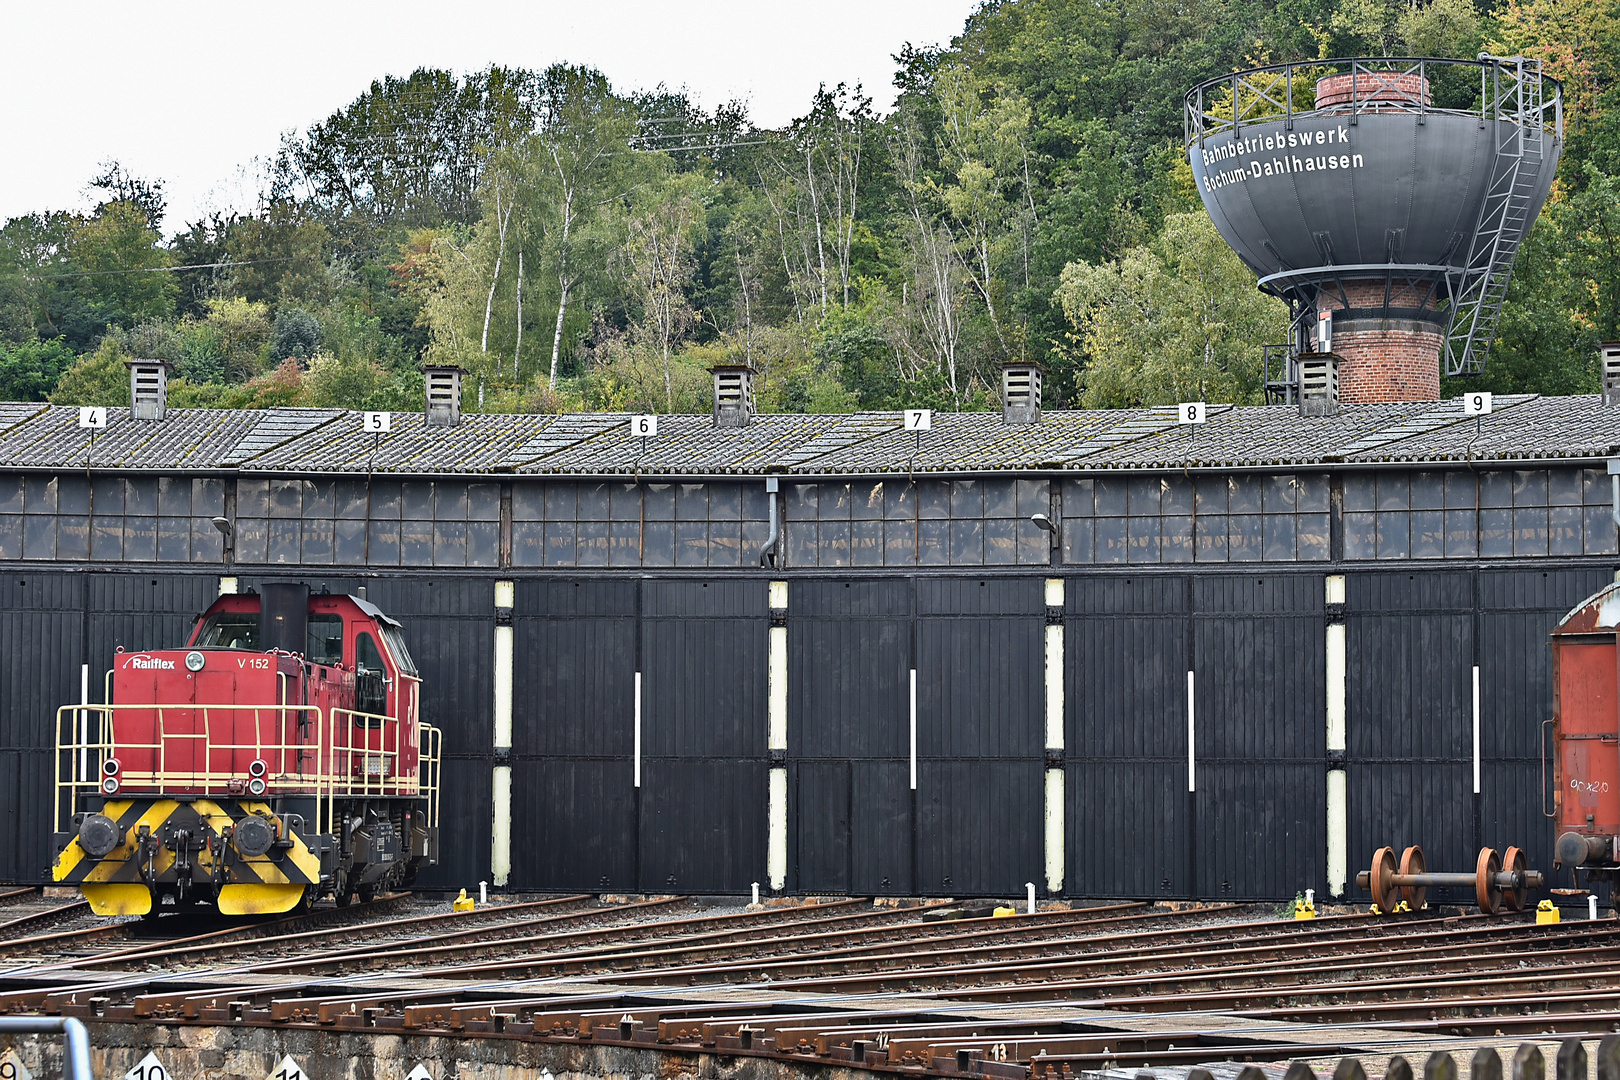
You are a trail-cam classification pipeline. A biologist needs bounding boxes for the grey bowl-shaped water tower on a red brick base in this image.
[1186,55,1563,405]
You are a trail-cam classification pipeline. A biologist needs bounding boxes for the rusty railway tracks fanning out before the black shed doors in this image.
[0,897,1620,1080]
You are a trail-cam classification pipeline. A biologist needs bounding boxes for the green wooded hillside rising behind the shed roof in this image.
[0,0,1620,413]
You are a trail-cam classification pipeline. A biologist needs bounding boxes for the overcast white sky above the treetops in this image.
[0,0,977,230]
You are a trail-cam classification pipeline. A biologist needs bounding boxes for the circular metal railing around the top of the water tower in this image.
[1183,53,1563,147]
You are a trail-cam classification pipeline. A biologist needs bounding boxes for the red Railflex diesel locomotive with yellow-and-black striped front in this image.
[52,583,439,915]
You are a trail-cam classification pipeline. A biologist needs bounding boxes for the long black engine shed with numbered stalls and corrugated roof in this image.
[0,376,1620,900]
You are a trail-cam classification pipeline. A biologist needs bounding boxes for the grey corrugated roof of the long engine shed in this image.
[0,395,1620,476]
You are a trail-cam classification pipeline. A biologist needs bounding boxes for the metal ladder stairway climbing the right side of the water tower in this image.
[1445,57,1547,376]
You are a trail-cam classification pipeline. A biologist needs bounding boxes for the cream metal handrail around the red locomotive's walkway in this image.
[53,704,442,832]
